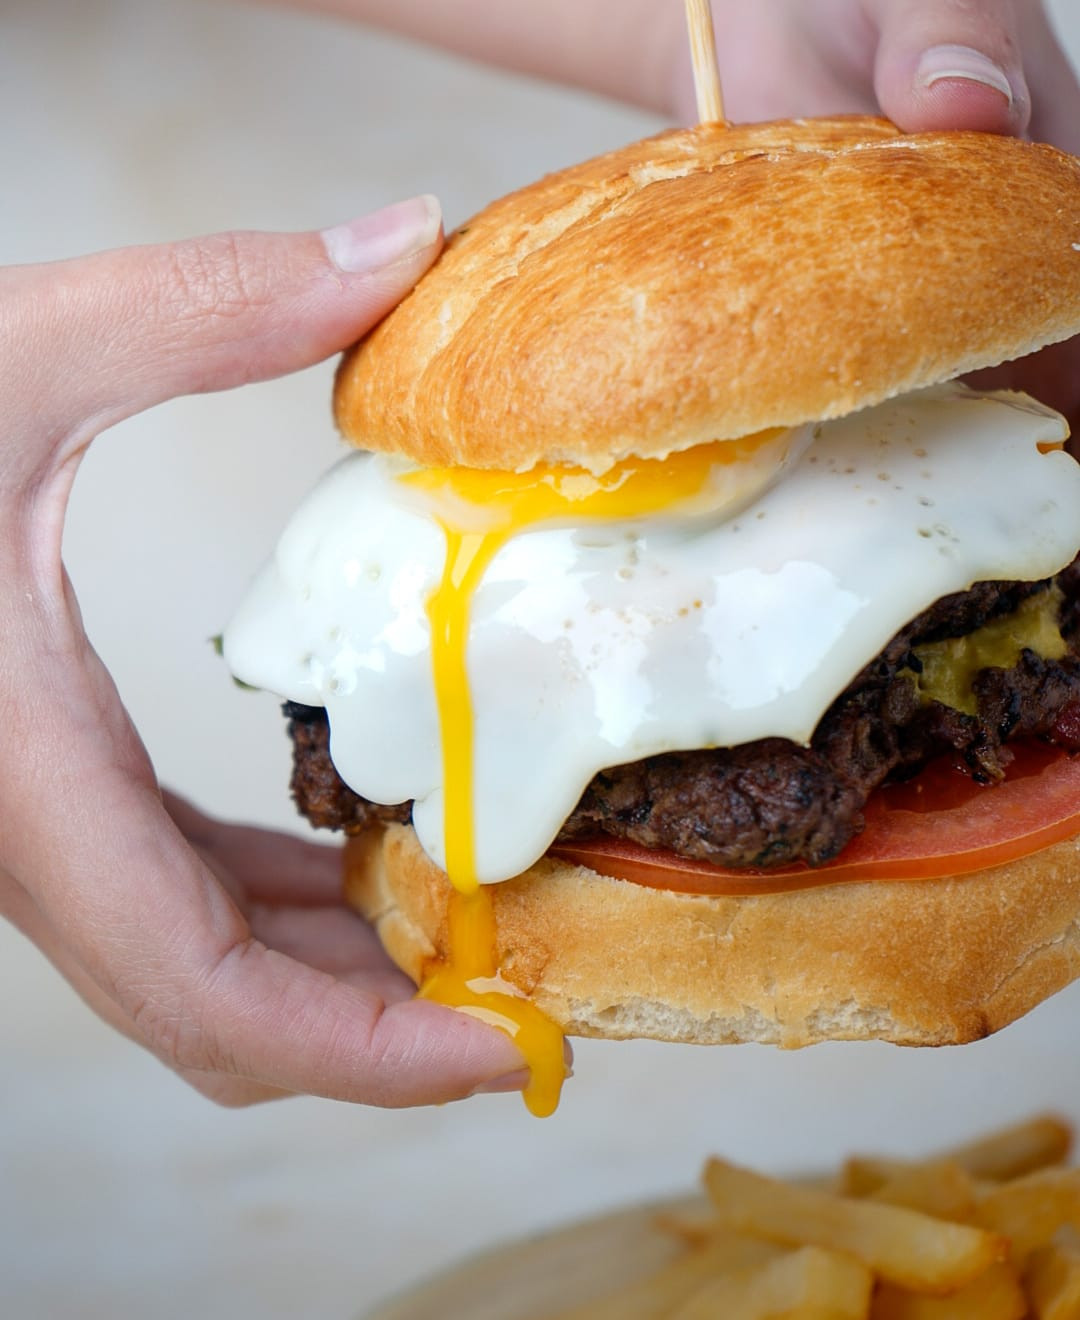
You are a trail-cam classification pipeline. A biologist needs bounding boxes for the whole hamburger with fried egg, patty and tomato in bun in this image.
[224,117,1080,1109]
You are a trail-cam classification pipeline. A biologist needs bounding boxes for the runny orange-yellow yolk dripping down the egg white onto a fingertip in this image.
[400,430,791,1115]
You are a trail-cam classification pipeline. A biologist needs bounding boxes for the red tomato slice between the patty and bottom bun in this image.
[551,742,1080,895]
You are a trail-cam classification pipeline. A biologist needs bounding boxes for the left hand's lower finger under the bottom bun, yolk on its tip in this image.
[16,751,522,1106]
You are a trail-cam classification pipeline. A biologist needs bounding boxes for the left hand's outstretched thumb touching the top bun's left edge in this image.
[0,197,442,480]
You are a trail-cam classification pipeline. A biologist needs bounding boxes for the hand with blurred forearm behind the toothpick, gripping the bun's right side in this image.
[315,0,1080,422]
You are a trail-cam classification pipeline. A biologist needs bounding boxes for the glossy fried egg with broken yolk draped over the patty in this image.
[224,384,1080,891]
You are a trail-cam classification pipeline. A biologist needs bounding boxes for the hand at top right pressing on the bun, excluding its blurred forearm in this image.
[675,0,1080,427]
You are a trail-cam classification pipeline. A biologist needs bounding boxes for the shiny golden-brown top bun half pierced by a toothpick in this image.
[334,117,1080,470]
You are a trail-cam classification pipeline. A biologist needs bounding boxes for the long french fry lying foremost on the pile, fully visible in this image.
[705,1159,1009,1292]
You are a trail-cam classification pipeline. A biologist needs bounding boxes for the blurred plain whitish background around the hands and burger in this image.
[0,0,1080,1320]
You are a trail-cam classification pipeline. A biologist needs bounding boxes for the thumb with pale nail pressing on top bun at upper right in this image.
[865,0,1031,133]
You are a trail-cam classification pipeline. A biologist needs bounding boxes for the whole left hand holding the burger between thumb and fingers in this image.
[0,199,524,1105]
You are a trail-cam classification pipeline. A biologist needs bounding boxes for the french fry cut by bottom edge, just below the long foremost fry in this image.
[669,1246,874,1320]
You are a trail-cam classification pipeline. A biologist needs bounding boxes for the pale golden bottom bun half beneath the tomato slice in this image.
[346,825,1080,1047]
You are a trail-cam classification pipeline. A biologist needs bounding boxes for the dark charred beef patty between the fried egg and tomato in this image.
[284,558,1080,867]
